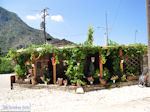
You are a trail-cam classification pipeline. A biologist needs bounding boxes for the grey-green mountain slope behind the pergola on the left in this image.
[0,7,74,52]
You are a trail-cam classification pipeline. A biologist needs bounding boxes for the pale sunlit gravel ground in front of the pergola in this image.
[0,86,150,112]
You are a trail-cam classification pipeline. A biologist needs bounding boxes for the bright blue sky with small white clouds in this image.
[0,0,147,45]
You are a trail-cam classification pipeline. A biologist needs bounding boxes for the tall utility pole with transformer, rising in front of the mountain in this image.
[40,8,49,44]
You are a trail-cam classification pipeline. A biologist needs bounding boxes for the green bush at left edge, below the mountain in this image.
[0,57,14,74]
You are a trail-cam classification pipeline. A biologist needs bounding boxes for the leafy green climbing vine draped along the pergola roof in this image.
[9,44,147,80]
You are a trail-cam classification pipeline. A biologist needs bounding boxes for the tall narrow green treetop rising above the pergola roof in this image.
[84,26,94,46]
